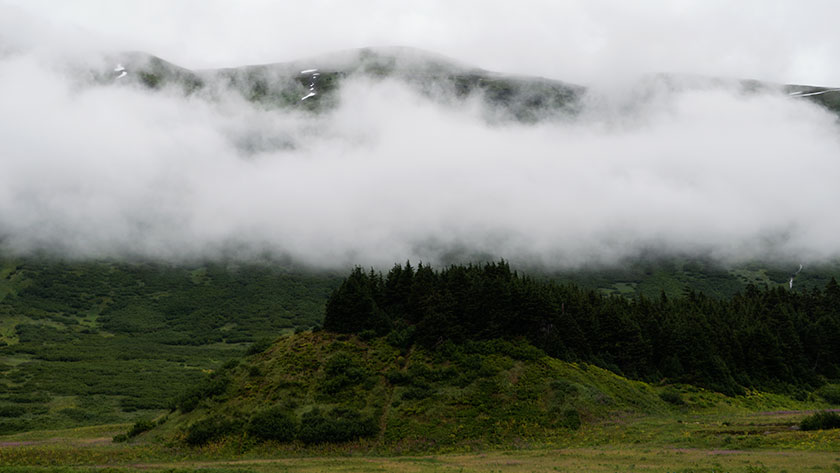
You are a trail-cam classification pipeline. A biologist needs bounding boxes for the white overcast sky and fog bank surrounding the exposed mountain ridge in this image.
[0,0,840,268]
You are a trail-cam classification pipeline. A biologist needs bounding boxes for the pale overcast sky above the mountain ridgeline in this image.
[0,0,840,85]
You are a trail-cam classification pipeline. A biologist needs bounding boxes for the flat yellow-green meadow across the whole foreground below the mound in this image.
[0,411,840,473]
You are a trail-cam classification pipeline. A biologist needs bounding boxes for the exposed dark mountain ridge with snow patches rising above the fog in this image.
[100,47,840,122]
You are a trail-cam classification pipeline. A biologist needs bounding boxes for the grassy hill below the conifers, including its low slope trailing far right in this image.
[139,332,828,455]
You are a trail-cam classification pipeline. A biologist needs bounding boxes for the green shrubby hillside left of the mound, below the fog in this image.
[0,258,338,433]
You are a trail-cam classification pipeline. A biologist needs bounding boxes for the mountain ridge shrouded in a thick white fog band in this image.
[0,43,840,266]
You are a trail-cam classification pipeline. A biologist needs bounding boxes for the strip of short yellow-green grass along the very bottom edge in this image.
[0,446,840,473]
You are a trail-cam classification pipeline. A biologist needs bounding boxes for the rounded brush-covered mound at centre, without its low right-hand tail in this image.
[156,332,668,450]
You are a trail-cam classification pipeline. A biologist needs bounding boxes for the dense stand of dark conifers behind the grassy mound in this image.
[324,261,840,394]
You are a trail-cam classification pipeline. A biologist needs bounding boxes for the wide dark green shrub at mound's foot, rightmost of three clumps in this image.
[298,408,379,444]
